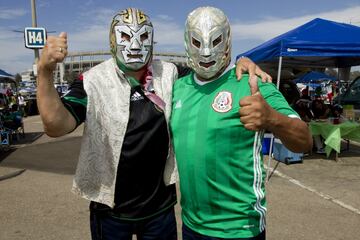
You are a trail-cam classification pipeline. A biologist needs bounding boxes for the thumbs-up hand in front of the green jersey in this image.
[239,83,274,131]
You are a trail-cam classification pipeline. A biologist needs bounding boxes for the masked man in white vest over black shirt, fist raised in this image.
[37,8,269,240]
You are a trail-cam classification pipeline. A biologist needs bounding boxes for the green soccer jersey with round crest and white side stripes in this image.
[170,69,297,238]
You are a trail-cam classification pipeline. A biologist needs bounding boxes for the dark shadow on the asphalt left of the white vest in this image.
[0,137,81,175]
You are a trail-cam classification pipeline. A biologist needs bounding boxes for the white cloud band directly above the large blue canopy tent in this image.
[232,6,360,41]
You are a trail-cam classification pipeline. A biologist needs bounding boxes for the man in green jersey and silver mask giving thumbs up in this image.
[170,7,312,240]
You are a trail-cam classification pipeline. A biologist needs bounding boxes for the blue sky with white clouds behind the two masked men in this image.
[0,0,360,74]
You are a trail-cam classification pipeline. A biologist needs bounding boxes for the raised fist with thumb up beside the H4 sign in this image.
[38,32,68,72]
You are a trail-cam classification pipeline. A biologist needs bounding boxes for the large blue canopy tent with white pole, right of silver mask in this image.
[238,18,360,179]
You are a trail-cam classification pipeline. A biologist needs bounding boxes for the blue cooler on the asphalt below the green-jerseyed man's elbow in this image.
[273,138,304,164]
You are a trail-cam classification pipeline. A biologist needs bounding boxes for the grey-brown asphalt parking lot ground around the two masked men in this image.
[0,116,360,240]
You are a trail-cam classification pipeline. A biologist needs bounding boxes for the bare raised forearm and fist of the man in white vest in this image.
[36,33,77,137]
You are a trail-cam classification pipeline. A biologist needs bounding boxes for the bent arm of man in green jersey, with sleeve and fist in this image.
[239,84,312,152]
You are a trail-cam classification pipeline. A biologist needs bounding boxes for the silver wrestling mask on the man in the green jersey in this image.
[185,7,231,80]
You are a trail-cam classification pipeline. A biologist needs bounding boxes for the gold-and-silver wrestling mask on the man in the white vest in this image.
[110,8,153,71]
